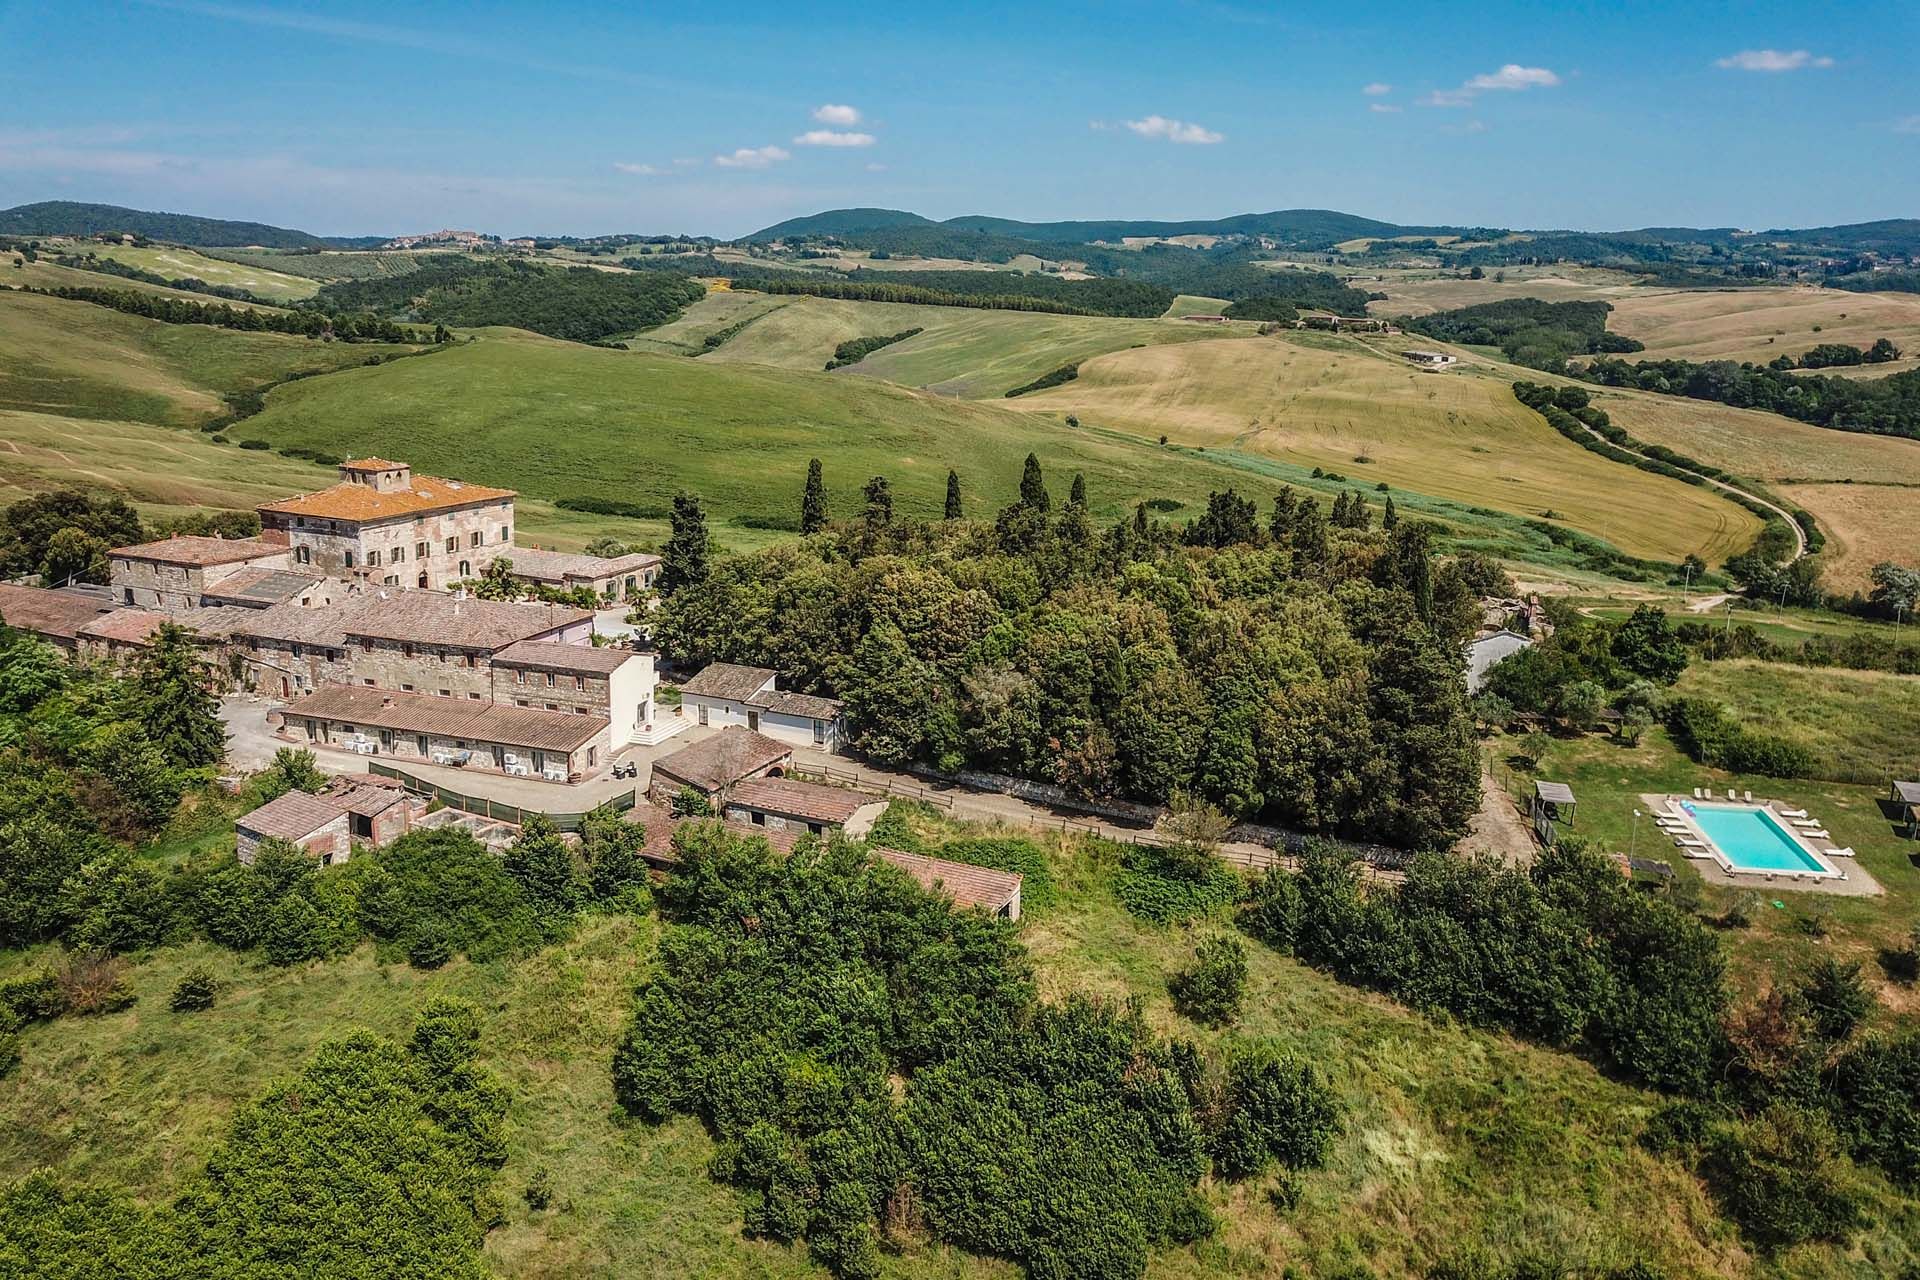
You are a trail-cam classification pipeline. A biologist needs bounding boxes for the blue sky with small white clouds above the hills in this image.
[0,0,1920,236]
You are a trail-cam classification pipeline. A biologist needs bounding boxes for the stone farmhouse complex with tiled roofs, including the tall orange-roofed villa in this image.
[0,459,839,781]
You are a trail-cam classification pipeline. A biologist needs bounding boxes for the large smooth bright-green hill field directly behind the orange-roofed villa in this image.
[224,335,1305,518]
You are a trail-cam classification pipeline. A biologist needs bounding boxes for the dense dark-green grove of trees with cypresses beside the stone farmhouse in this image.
[655,459,1498,848]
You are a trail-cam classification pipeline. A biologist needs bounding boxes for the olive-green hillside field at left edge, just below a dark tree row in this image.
[0,287,409,426]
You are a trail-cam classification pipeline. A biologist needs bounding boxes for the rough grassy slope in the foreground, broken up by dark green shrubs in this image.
[0,817,1920,1280]
